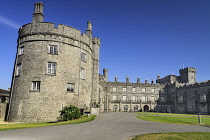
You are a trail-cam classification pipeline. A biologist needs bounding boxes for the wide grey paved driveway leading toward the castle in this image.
[0,112,210,140]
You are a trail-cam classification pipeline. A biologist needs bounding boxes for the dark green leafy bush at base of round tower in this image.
[58,105,81,121]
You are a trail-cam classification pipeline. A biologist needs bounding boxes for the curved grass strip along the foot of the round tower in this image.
[0,115,96,131]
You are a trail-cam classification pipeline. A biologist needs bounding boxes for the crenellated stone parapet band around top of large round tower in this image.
[19,22,92,46]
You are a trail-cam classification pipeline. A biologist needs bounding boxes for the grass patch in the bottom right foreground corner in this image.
[132,132,210,140]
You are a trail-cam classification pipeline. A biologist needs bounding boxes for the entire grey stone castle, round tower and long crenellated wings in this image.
[6,2,210,122]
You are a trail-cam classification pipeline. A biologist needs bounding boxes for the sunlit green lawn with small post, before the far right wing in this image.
[137,112,210,126]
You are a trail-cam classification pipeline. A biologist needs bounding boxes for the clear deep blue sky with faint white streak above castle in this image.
[0,0,210,89]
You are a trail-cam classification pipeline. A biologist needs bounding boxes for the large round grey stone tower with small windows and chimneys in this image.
[7,2,100,122]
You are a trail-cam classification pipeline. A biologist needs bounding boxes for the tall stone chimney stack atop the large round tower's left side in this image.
[32,2,44,23]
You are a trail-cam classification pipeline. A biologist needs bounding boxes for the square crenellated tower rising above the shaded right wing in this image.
[179,67,196,84]
